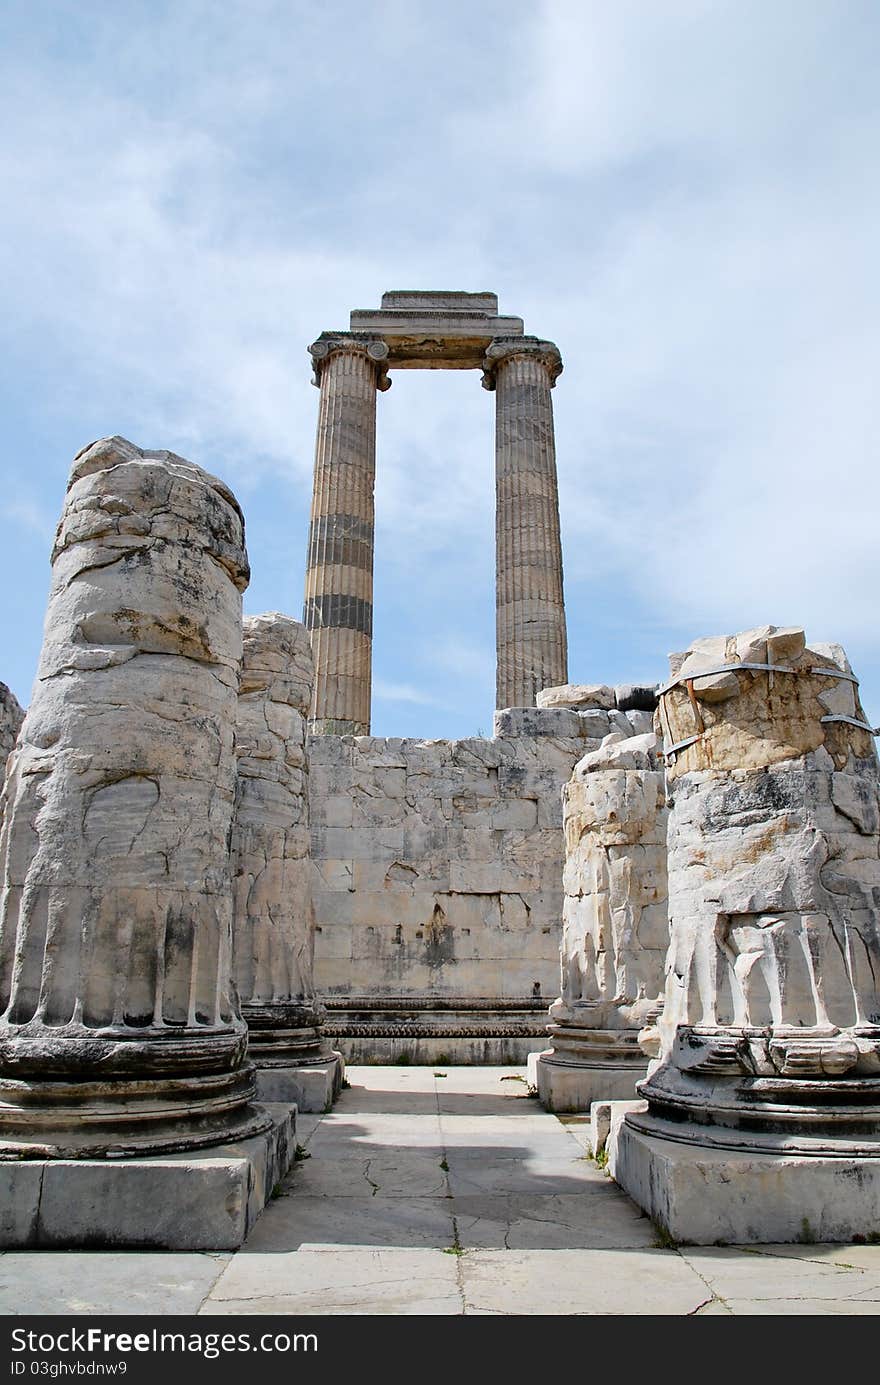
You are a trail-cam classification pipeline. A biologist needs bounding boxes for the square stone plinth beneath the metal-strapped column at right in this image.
[613,1115,880,1245]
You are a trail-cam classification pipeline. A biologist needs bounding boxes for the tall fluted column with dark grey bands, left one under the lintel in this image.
[302,335,389,735]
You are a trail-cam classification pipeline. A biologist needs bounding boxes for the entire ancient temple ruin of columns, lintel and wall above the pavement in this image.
[0,294,880,1249]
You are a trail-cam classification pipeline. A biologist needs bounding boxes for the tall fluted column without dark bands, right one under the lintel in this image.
[482,337,568,708]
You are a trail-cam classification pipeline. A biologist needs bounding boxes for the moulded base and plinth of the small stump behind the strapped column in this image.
[528,1028,647,1112]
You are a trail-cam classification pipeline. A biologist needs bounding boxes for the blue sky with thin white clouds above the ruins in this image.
[0,0,880,735]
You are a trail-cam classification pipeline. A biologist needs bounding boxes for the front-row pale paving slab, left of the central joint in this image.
[201,1249,461,1316]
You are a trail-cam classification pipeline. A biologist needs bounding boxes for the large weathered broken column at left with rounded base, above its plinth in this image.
[0,438,272,1159]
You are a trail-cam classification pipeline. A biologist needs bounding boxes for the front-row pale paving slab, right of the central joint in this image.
[460,1249,712,1316]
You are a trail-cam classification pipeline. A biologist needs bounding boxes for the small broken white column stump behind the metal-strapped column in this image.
[529,734,668,1111]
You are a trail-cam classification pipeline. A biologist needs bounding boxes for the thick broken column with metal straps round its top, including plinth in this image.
[617,626,880,1241]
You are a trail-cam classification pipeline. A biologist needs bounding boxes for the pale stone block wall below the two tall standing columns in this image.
[309,690,650,1061]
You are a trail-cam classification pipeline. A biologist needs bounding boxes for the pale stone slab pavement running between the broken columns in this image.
[0,1066,880,1316]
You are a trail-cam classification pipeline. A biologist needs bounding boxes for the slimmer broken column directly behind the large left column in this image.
[231,612,342,1111]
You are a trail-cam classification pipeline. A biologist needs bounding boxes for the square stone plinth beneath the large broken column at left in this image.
[0,1105,297,1251]
